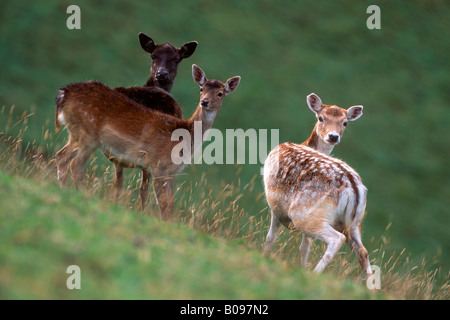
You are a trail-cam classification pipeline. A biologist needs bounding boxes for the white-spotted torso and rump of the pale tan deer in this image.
[264,143,366,228]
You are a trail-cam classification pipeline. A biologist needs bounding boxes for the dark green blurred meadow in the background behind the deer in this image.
[0,0,450,298]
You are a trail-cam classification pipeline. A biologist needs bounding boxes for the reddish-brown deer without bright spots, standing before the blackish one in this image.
[56,65,240,219]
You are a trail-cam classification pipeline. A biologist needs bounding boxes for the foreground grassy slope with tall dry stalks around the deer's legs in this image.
[0,115,450,299]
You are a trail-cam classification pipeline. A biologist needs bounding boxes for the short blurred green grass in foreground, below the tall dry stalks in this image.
[0,171,382,299]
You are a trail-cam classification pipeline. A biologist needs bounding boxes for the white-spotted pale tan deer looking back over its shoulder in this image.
[264,94,372,274]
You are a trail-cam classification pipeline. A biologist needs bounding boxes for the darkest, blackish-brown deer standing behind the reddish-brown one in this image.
[111,32,197,201]
